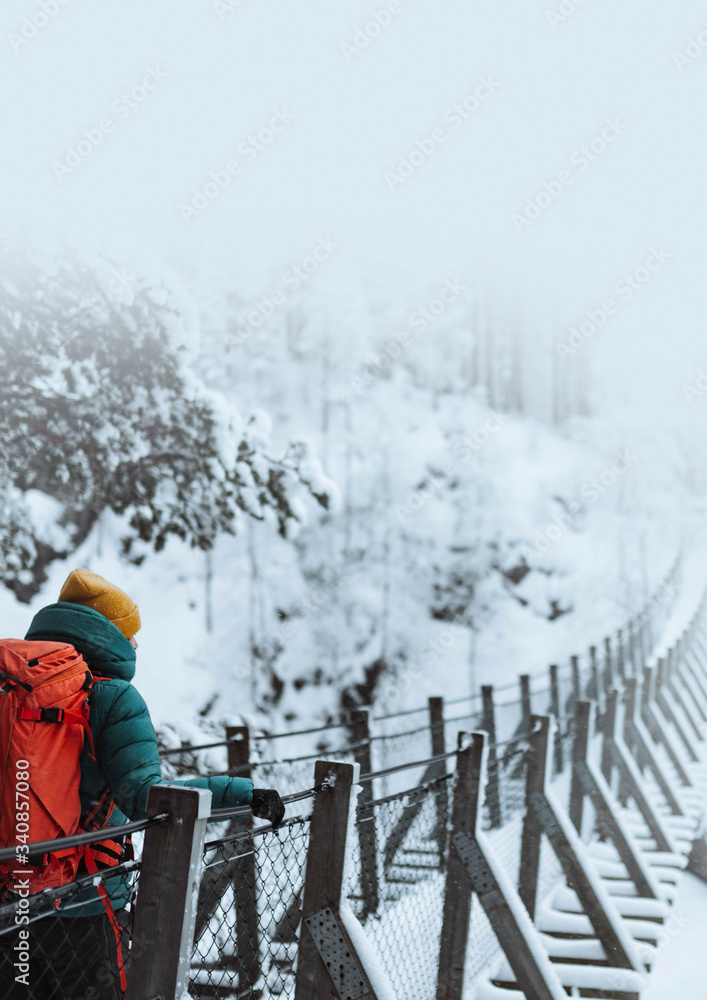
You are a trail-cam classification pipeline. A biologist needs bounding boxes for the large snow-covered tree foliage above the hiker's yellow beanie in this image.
[0,240,333,600]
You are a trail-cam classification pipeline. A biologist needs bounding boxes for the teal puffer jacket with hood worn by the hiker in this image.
[26,601,253,917]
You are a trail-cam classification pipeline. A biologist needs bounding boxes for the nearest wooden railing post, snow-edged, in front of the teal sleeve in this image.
[126,785,211,1000]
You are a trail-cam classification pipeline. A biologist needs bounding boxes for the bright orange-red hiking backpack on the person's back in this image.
[0,639,122,896]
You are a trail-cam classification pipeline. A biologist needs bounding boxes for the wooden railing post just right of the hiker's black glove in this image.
[295,760,384,1000]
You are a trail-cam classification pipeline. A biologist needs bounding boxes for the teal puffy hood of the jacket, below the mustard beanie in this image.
[25,601,135,681]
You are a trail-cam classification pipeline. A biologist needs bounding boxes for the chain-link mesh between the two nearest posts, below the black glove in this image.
[189,817,309,1000]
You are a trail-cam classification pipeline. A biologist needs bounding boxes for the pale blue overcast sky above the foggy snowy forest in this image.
[0,0,707,406]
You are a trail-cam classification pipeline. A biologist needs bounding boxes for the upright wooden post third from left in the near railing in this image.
[436,733,484,1000]
